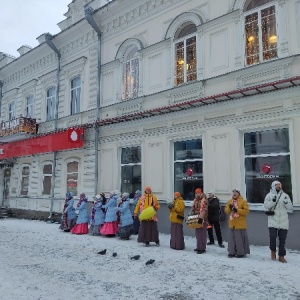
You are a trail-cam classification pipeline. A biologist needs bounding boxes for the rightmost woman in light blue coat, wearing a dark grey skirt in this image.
[115,193,133,240]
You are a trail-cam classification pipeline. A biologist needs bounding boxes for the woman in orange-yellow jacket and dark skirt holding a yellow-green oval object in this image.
[134,186,160,247]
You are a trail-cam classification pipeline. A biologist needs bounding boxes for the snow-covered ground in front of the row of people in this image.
[0,219,300,300]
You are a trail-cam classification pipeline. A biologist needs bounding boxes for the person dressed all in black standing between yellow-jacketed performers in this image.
[207,191,225,248]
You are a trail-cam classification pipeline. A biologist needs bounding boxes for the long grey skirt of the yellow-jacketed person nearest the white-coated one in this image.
[228,229,250,255]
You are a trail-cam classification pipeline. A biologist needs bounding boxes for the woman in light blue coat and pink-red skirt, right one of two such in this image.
[100,191,119,237]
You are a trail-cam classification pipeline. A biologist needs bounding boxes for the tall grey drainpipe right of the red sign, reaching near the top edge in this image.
[84,6,101,195]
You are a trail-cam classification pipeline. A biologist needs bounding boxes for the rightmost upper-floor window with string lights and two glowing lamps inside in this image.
[245,0,277,65]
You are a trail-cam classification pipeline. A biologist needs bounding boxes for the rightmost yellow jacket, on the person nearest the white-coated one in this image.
[225,195,249,229]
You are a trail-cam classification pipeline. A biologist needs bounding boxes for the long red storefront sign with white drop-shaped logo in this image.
[0,128,84,159]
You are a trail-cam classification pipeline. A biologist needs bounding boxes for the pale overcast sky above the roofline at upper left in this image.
[0,0,72,57]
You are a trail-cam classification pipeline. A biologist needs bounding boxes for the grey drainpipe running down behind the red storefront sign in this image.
[45,33,61,220]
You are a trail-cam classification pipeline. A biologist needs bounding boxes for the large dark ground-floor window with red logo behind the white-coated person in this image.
[244,128,292,203]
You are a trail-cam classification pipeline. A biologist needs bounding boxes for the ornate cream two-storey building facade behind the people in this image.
[0,0,300,249]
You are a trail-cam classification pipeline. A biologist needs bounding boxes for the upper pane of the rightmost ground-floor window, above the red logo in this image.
[244,128,290,155]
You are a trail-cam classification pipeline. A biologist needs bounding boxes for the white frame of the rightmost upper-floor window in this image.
[243,1,280,66]
